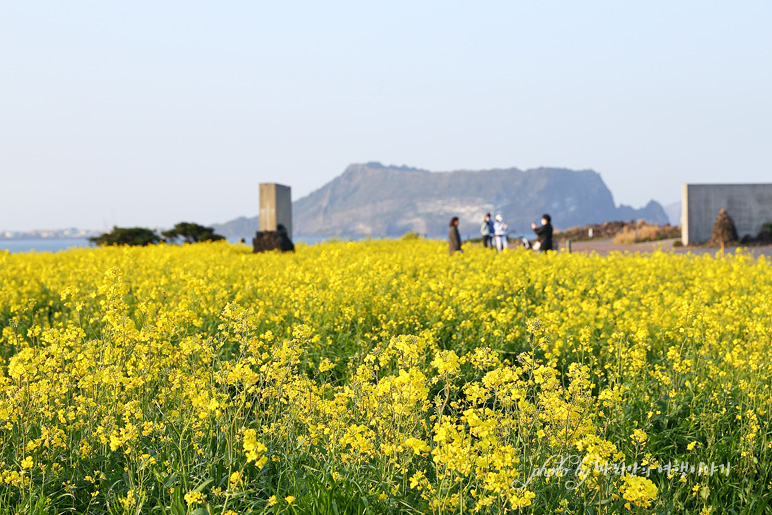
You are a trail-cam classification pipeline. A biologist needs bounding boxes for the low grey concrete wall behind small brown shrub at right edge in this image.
[681,184,772,245]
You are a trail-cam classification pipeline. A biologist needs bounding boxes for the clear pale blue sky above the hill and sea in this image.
[0,0,772,230]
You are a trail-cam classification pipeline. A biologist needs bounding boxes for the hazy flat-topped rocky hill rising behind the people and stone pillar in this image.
[215,163,668,238]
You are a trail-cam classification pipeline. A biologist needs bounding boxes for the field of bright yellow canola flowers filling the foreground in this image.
[0,239,772,515]
